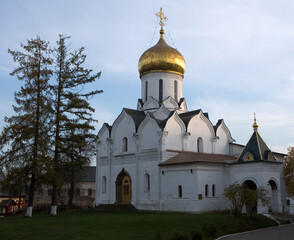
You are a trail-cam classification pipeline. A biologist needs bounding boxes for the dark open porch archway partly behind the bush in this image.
[242,180,258,215]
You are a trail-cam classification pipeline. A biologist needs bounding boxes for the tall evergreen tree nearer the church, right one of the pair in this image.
[51,35,102,216]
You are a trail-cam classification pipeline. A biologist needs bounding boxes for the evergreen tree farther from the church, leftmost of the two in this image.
[0,37,52,217]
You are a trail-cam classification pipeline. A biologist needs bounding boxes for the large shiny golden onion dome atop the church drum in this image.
[138,29,186,77]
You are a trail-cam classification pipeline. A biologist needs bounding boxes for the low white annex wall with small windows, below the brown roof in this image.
[160,164,227,212]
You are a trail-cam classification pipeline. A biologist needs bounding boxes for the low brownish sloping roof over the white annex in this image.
[159,151,236,166]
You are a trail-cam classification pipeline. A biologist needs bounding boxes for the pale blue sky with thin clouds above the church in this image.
[0,0,294,153]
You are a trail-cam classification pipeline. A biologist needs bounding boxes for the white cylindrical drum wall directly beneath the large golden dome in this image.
[141,72,183,102]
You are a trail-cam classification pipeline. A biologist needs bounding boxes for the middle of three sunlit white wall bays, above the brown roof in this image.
[186,114,214,153]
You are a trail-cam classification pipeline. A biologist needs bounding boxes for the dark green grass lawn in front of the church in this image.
[0,210,276,240]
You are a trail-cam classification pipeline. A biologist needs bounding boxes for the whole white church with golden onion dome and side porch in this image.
[94,10,293,213]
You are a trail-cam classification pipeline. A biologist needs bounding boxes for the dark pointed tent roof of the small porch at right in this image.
[237,131,277,162]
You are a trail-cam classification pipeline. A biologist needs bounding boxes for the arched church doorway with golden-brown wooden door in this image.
[115,169,132,203]
